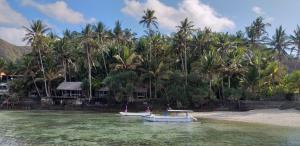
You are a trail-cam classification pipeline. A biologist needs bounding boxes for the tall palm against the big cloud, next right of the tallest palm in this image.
[177,18,194,85]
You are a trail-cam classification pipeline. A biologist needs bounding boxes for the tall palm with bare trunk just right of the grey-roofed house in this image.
[81,24,95,100]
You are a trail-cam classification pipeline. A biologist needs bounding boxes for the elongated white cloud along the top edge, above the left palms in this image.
[22,0,95,24]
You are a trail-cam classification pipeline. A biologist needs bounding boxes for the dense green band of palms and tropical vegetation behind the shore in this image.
[0,10,300,107]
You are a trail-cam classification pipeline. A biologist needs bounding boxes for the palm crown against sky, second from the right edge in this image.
[270,26,290,61]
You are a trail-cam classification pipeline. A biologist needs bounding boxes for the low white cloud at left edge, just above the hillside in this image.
[0,27,26,46]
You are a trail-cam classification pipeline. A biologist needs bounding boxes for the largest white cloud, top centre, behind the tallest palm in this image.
[121,0,235,31]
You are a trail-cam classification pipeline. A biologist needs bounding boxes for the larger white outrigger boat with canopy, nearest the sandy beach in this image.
[144,110,197,122]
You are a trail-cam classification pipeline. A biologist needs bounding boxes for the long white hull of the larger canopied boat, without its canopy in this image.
[144,114,197,122]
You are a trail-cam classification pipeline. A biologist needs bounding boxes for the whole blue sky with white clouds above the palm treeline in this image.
[0,0,300,45]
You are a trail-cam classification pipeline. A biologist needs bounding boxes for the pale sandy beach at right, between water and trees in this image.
[193,109,300,127]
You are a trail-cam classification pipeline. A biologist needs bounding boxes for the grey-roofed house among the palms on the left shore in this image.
[53,82,84,104]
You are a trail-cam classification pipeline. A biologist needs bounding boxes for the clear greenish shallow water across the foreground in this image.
[0,111,300,146]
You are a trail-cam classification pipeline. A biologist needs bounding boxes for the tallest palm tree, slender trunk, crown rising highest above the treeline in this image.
[140,9,158,97]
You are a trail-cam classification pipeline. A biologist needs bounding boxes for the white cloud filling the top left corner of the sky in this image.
[0,0,28,26]
